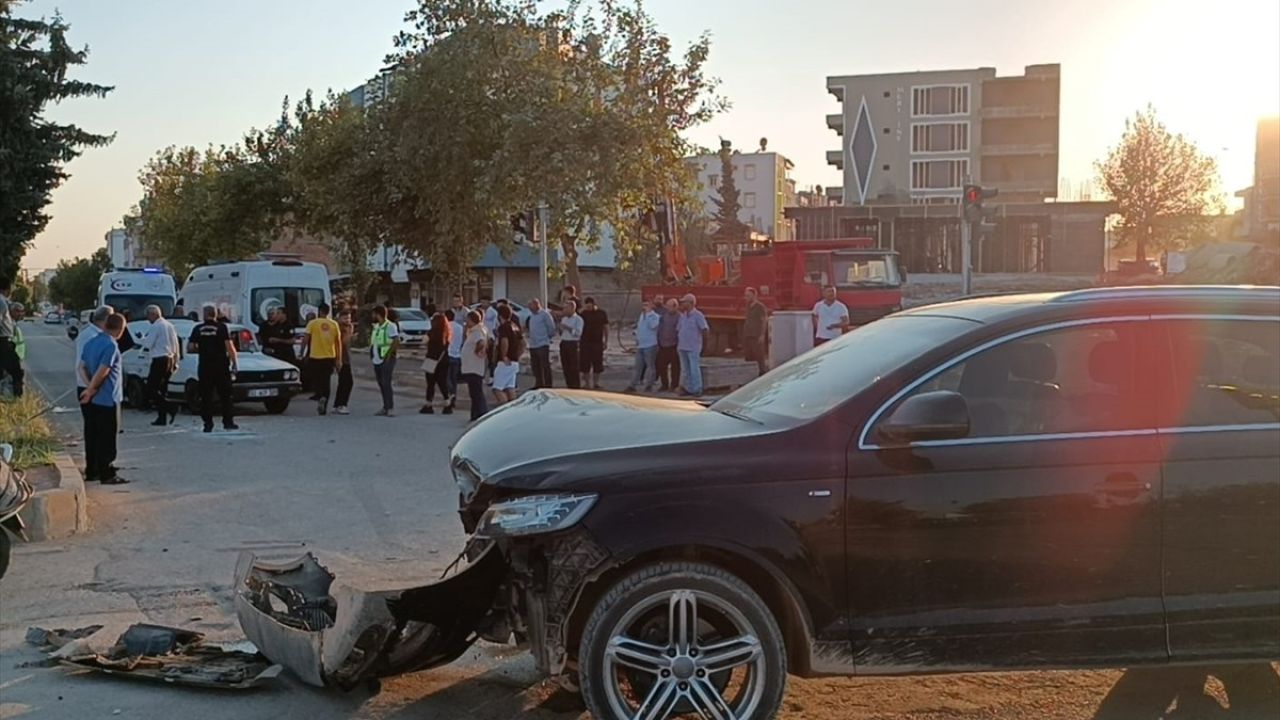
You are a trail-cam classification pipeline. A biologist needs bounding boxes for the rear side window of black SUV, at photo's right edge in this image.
[1165,320,1280,427]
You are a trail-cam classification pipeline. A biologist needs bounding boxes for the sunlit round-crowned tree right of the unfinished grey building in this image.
[1097,106,1224,261]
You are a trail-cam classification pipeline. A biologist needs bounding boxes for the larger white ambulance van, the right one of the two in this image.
[178,259,333,334]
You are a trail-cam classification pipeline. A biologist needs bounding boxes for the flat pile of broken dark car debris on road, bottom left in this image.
[27,624,282,691]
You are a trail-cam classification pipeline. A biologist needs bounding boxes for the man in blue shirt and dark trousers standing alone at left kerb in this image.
[79,315,128,486]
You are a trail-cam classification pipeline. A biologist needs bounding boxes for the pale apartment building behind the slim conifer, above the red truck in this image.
[686,151,796,242]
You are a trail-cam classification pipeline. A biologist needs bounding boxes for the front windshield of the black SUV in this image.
[710,315,974,420]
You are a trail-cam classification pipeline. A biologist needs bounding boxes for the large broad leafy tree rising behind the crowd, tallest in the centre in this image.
[376,0,724,287]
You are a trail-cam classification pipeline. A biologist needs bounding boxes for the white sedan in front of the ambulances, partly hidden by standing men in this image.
[122,320,302,414]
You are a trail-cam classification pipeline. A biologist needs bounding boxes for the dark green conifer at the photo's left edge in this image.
[0,0,114,281]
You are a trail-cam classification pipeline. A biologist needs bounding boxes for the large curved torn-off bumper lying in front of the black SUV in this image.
[234,547,507,689]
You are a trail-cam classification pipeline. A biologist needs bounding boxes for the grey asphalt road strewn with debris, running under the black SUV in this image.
[0,324,1276,720]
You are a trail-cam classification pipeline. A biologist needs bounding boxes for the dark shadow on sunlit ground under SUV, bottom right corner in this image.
[1093,664,1280,720]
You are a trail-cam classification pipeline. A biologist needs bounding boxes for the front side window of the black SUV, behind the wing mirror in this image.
[886,323,1152,438]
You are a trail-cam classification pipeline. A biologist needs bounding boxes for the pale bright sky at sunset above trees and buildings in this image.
[18,0,1280,269]
